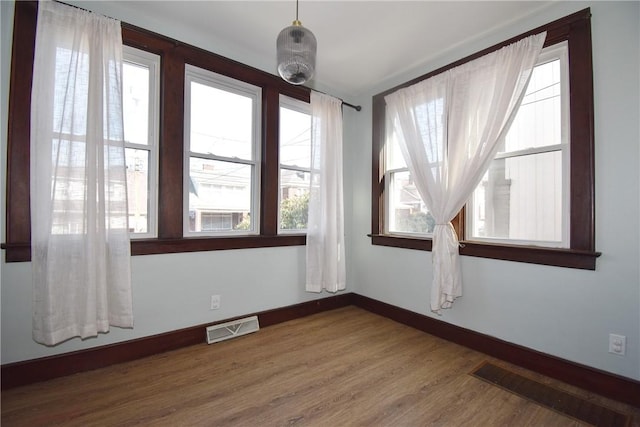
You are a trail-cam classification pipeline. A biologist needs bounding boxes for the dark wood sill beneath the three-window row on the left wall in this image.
[2,234,307,262]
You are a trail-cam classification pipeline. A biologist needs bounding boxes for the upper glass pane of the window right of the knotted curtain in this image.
[500,60,562,152]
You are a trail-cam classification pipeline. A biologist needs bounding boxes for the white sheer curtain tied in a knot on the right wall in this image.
[385,33,546,312]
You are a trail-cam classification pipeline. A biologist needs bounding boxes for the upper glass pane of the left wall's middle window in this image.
[189,82,254,160]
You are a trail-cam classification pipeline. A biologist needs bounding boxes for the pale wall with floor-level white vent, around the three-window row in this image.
[0,1,338,364]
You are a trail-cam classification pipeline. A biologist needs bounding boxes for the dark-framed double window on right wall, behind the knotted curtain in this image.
[371,9,600,269]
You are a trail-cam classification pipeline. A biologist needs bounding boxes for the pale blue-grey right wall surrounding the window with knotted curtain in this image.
[345,2,640,379]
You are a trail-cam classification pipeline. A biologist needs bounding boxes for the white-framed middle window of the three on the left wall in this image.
[184,65,261,235]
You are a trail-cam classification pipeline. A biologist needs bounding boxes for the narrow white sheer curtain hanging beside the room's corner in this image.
[306,91,345,292]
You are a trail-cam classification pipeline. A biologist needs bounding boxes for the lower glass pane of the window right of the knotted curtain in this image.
[467,151,563,243]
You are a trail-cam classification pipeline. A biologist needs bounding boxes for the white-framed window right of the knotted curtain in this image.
[465,42,569,247]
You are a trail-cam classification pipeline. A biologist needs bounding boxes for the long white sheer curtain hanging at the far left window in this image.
[31,1,133,345]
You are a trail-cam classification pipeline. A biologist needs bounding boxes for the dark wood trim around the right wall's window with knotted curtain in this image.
[371,8,600,270]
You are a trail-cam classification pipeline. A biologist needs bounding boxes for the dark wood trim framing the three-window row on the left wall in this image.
[2,1,310,262]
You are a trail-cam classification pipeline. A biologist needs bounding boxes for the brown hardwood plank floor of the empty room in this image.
[1,306,640,426]
